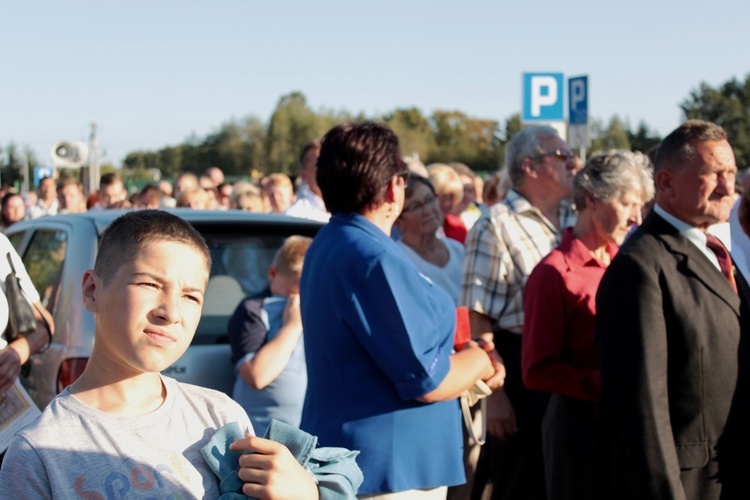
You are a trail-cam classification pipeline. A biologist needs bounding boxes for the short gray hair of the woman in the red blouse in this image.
[573,149,654,211]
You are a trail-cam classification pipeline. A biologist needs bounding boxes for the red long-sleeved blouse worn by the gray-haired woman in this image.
[521,228,617,401]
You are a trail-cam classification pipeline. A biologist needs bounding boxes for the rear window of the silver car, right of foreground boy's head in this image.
[193,232,287,344]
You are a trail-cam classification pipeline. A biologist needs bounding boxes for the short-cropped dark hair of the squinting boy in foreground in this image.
[94,210,211,284]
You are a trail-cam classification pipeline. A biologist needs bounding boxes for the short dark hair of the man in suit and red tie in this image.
[654,120,728,172]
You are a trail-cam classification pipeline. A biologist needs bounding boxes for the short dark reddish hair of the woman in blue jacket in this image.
[316,122,407,213]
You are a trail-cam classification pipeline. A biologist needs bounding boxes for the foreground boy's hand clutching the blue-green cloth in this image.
[229,434,318,500]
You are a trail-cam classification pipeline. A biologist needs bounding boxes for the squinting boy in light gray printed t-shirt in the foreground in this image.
[0,210,318,498]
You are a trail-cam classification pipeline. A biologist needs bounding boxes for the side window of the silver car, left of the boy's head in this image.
[23,229,68,312]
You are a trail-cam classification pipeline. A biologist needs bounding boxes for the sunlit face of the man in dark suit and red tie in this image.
[657,141,737,229]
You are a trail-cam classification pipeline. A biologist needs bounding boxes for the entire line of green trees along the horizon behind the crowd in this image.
[0,75,750,189]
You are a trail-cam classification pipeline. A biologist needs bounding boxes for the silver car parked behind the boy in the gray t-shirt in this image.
[5,209,322,408]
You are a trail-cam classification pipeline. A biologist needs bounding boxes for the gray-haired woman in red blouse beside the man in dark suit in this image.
[521,150,654,500]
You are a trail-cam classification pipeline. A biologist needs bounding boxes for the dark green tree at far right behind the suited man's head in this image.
[680,74,750,168]
